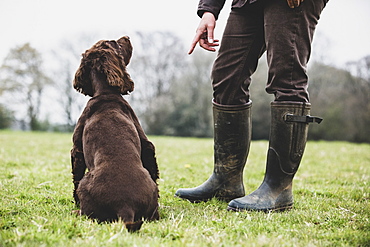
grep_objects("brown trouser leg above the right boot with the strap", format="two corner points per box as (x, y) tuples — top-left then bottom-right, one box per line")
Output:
(264, 0), (327, 102)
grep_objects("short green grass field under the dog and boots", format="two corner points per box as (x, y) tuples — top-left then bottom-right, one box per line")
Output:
(0, 131), (370, 247)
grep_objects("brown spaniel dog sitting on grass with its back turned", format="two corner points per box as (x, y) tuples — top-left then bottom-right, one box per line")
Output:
(71, 37), (159, 231)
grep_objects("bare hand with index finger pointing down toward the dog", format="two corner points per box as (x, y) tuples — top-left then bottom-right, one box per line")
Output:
(188, 12), (219, 55)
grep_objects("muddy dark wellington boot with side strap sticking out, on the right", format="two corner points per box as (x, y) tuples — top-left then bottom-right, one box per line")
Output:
(228, 102), (322, 211)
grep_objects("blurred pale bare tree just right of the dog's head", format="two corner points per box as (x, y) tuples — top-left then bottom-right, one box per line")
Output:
(128, 32), (185, 129)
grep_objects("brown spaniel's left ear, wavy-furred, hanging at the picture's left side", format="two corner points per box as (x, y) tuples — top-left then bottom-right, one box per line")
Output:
(73, 51), (93, 96)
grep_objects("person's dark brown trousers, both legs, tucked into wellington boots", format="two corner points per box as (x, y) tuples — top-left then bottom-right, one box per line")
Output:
(212, 0), (328, 105)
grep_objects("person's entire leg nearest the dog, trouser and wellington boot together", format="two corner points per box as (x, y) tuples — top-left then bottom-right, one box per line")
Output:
(175, 4), (264, 201)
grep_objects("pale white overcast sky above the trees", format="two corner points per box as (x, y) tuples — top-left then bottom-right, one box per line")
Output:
(0, 0), (370, 66)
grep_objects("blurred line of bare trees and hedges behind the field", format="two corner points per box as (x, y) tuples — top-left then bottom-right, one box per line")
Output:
(0, 32), (370, 143)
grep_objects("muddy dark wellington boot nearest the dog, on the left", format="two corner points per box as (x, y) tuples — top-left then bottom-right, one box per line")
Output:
(175, 102), (252, 202)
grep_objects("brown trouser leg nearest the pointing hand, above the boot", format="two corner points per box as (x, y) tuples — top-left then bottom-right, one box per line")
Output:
(212, 1), (265, 105)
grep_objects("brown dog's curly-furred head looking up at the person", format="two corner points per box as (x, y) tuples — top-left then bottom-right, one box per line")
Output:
(73, 36), (134, 96)
